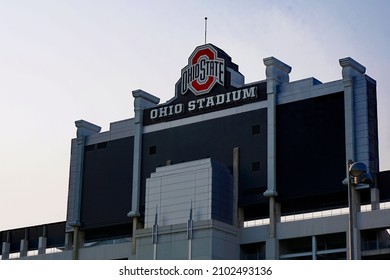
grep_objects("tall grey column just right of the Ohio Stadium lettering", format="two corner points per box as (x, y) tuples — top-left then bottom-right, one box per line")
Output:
(264, 57), (291, 259)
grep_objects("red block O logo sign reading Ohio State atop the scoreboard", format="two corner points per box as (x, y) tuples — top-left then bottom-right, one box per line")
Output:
(180, 45), (225, 95)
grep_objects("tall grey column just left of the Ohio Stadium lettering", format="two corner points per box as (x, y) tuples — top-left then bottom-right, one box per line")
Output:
(127, 89), (160, 255)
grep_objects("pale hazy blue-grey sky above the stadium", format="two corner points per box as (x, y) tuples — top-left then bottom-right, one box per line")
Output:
(0, 0), (390, 231)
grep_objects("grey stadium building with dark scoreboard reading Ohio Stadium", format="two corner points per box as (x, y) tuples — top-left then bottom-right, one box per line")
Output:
(0, 44), (390, 260)
